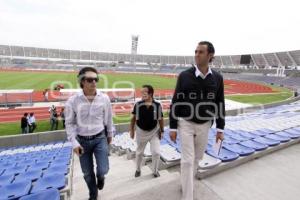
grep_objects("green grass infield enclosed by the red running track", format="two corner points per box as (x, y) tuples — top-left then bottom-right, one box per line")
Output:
(0, 71), (176, 90)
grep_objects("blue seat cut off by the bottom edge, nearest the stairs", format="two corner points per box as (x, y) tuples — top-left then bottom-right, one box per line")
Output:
(19, 188), (60, 200)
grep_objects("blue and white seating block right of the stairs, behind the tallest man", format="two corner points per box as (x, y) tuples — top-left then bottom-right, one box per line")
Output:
(113, 101), (300, 169)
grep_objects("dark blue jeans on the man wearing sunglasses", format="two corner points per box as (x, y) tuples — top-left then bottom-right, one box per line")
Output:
(77, 134), (109, 199)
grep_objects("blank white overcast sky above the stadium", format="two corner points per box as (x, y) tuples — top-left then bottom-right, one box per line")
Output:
(0, 0), (300, 55)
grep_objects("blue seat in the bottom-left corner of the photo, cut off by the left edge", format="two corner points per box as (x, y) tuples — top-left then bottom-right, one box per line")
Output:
(0, 181), (31, 200)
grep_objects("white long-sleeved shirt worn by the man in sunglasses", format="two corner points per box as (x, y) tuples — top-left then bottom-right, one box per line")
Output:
(65, 91), (113, 148)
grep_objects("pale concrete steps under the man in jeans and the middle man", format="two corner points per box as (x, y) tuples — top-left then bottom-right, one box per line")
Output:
(71, 154), (180, 200)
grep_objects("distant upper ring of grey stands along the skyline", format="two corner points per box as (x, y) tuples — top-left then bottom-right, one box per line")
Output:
(0, 45), (300, 68)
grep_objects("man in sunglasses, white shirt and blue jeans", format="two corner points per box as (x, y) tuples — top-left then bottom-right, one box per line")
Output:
(65, 67), (113, 200)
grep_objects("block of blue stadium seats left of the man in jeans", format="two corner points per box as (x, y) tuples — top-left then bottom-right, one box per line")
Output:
(0, 142), (72, 200)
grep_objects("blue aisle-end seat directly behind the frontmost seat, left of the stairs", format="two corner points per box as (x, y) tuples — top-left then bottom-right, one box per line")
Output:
(31, 174), (66, 193)
